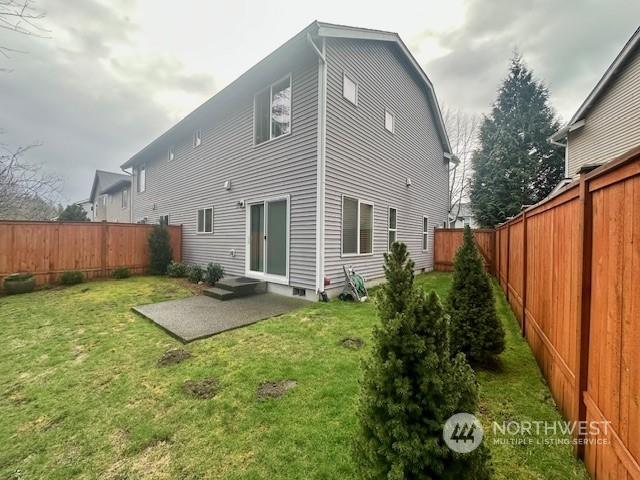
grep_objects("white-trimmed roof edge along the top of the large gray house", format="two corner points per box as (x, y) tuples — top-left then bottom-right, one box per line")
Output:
(121, 21), (452, 168)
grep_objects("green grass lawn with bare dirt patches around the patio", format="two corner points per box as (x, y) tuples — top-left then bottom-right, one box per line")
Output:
(0, 274), (586, 479)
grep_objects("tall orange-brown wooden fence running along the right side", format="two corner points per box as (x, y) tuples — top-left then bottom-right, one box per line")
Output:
(436, 144), (640, 479)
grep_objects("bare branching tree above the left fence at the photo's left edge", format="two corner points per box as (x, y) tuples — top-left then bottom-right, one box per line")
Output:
(0, 137), (60, 220)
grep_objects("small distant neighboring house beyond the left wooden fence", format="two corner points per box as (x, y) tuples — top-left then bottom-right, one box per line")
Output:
(89, 170), (131, 223)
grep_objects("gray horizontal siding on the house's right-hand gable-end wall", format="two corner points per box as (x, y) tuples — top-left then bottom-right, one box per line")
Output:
(325, 39), (448, 286)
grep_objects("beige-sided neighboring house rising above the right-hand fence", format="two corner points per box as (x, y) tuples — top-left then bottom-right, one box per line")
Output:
(550, 28), (640, 179)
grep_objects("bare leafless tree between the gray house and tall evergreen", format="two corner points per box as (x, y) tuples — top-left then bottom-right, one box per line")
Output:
(443, 108), (480, 226)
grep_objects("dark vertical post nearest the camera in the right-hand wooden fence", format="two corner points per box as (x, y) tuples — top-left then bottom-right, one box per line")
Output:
(574, 174), (593, 458)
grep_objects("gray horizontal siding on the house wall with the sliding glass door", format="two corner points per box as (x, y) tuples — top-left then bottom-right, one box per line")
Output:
(133, 54), (318, 288)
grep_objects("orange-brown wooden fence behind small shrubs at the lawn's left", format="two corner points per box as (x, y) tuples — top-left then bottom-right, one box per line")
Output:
(0, 221), (182, 284)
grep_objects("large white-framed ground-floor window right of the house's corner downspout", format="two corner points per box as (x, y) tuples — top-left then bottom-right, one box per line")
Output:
(342, 197), (373, 255)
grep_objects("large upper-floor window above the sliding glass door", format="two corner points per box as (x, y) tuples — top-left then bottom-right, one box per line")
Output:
(253, 75), (291, 145)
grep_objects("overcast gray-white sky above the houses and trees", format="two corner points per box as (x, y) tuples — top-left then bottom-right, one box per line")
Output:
(0, 0), (640, 201)
